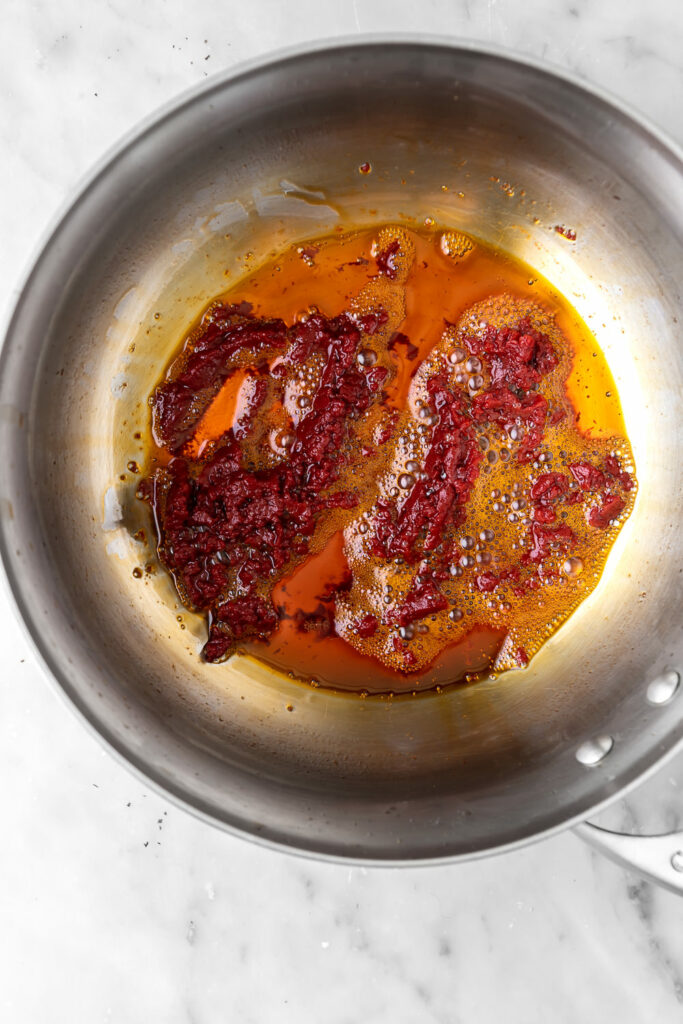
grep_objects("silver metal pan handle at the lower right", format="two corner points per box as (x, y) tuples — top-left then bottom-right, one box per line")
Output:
(573, 821), (683, 896)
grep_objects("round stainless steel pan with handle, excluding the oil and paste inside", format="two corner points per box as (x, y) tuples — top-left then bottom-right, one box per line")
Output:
(0, 39), (683, 890)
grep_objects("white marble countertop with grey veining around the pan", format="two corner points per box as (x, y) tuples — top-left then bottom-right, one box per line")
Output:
(0, 0), (683, 1024)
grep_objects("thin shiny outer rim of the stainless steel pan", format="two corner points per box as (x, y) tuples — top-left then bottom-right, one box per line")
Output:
(0, 33), (683, 867)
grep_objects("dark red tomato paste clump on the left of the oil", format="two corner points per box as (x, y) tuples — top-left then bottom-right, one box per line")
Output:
(152, 307), (393, 660)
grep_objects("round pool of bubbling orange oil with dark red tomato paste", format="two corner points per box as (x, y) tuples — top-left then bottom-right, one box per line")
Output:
(141, 226), (635, 691)
